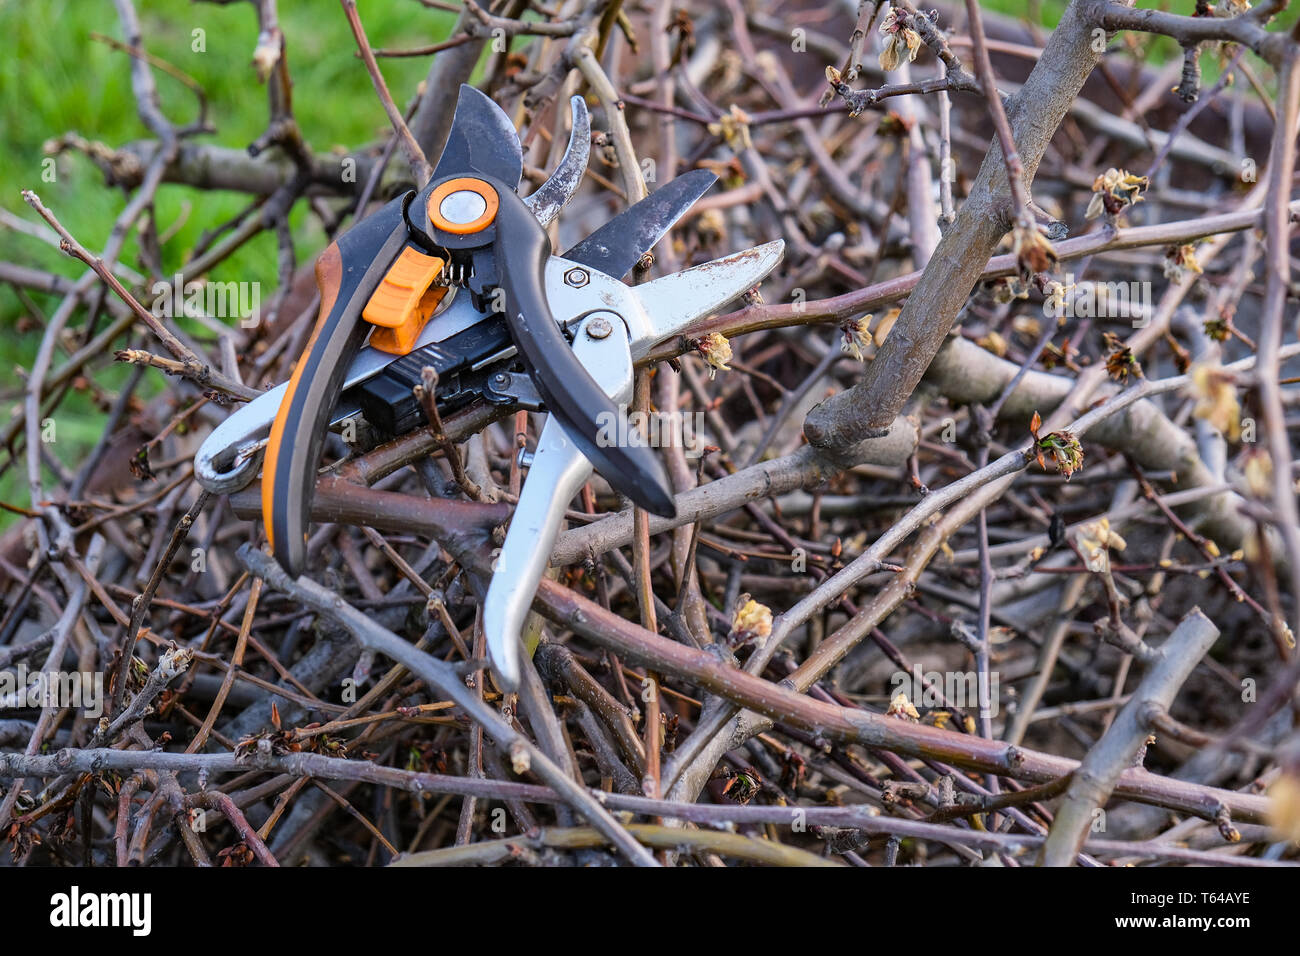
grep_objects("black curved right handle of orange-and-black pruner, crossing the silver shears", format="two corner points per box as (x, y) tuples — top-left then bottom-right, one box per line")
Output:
(494, 190), (677, 518)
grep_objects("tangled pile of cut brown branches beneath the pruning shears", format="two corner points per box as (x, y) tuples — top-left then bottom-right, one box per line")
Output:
(0, 0), (1300, 866)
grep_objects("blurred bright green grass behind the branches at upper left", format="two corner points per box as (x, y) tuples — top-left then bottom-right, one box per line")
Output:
(0, 0), (455, 515)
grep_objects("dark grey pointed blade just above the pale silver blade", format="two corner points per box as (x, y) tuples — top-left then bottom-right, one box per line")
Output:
(563, 169), (718, 278)
